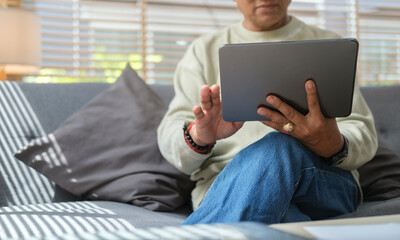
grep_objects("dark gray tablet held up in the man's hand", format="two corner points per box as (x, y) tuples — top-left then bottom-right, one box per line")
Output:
(219, 38), (358, 122)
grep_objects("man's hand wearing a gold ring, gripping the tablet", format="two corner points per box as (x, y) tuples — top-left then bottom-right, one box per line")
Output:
(257, 80), (344, 158)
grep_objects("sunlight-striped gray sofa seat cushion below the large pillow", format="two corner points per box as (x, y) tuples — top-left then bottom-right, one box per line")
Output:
(0, 201), (186, 239)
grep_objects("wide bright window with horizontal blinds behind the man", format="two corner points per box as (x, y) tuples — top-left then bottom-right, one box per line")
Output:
(18, 0), (400, 84)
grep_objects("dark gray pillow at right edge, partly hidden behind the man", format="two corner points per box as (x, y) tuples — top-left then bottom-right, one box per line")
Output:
(358, 142), (400, 201)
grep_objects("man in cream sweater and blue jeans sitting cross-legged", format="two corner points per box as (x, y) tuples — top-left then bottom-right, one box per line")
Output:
(158, 0), (377, 224)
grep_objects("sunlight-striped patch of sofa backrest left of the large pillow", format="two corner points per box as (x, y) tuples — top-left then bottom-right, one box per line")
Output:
(0, 82), (55, 206)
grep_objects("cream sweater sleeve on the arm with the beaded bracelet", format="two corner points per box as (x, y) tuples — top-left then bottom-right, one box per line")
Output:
(157, 41), (211, 174)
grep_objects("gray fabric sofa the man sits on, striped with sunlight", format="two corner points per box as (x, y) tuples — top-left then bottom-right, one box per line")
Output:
(0, 72), (400, 239)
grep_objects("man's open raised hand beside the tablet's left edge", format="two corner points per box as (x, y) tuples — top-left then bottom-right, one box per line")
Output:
(189, 85), (244, 146)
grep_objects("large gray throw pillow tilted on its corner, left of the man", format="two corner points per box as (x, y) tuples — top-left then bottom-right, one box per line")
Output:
(15, 65), (193, 211)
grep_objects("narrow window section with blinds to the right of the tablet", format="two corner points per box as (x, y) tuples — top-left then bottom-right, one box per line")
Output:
(358, 0), (400, 84)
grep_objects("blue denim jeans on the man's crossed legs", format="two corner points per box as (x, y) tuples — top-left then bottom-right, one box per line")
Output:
(183, 132), (359, 225)
